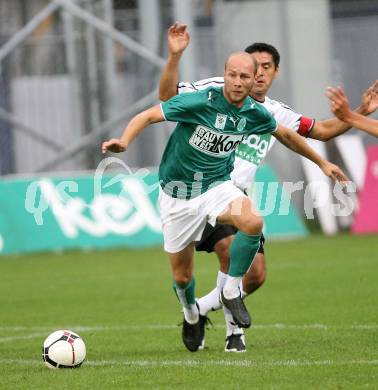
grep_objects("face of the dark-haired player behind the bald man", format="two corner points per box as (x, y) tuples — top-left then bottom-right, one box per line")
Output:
(251, 51), (278, 99)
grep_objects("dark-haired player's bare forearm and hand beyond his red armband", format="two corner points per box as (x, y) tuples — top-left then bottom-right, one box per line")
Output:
(309, 80), (378, 141)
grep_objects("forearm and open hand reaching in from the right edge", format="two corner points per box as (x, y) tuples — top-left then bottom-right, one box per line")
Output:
(326, 87), (378, 137)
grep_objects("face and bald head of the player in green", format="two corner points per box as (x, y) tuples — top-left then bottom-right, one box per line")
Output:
(224, 58), (254, 107)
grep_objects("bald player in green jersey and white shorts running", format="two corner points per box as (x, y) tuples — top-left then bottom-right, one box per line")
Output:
(102, 52), (347, 351)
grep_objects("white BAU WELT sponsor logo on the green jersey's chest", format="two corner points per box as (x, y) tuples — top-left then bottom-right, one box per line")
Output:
(189, 126), (244, 157)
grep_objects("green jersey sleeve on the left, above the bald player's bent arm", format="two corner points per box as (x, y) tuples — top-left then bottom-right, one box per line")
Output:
(160, 92), (206, 123)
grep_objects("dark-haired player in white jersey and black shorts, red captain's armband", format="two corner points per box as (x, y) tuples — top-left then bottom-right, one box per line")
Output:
(159, 23), (378, 352)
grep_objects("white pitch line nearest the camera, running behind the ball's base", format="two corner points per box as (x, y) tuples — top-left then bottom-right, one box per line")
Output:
(0, 359), (378, 368)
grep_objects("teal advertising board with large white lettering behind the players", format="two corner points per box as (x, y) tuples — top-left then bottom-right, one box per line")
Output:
(0, 166), (307, 254)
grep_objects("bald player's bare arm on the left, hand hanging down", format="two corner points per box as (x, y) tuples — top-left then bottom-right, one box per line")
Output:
(101, 105), (165, 153)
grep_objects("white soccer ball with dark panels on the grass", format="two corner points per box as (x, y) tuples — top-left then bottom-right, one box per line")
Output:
(42, 330), (86, 368)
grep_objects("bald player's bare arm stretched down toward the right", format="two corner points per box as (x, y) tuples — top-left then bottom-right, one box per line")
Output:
(273, 125), (349, 183)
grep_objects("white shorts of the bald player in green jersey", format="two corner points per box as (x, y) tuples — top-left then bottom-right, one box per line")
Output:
(159, 180), (246, 253)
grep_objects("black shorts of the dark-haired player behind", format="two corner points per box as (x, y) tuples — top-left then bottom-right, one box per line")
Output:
(196, 223), (265, 253)
